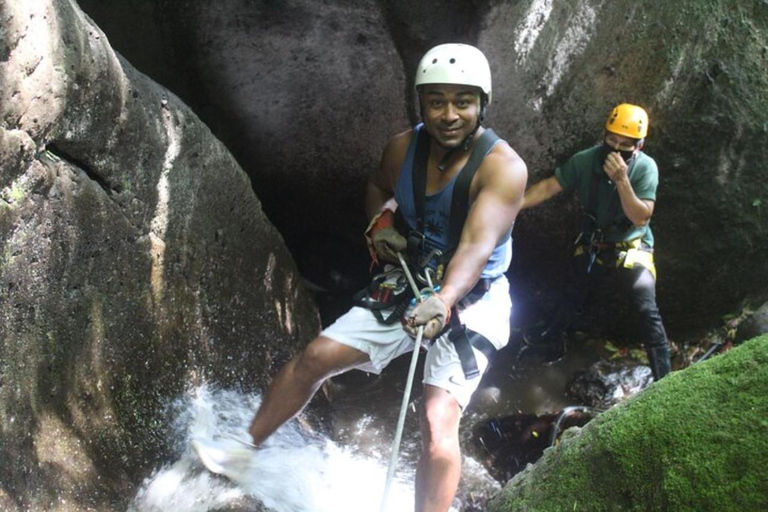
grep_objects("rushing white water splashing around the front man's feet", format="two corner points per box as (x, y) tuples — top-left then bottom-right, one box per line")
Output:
(129, 387), (420, 512)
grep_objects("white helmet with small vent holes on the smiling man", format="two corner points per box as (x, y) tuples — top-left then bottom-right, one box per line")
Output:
(416, 44), (491, 104)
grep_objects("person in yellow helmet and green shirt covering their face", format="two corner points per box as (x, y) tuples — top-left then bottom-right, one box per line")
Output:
(523, 103), (670, 380)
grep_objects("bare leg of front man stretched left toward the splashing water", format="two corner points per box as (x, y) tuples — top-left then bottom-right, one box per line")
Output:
(249, 336), (368, 446)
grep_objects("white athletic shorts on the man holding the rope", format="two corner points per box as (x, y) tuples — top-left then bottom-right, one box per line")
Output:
(321, 276), (512, 409)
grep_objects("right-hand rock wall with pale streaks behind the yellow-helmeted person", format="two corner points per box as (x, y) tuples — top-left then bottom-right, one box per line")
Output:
(478, 0), (768, 335)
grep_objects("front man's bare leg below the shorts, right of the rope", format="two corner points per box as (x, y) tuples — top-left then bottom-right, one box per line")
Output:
(416, 384), (461, 512)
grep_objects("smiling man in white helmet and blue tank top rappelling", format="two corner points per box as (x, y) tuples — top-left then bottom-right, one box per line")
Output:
(213, 44), (527, 512)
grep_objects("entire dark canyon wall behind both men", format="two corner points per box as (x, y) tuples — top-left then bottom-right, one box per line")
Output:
(82, 0), (768, 333)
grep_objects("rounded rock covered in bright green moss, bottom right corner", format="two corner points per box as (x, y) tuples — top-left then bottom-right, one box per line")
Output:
(488, 336), (768, 512)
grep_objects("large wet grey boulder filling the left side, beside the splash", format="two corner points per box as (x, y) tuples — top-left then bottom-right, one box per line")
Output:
(0, 0), (318, 510)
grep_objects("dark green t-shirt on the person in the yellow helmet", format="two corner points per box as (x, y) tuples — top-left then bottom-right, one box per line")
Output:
(555, 146), (659, 247)
